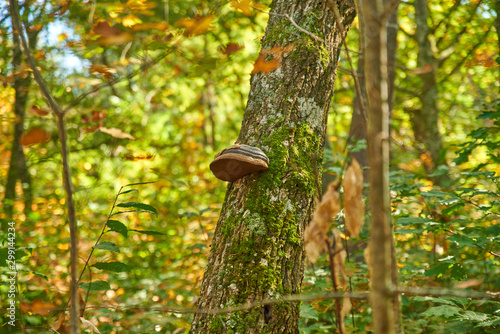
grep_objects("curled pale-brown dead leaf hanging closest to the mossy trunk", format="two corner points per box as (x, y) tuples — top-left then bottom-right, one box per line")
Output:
(304, 180), (340, 263)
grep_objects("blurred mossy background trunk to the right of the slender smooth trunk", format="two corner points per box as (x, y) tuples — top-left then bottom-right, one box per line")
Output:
(410, 0), (445, 173)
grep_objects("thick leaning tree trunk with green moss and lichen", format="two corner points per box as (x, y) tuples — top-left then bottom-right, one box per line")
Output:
(191, 0), (355, 333)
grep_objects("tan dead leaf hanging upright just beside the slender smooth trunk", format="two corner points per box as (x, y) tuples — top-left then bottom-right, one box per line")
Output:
(343, 158), (365, 237)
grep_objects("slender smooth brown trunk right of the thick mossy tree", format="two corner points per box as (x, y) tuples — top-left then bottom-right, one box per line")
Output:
(360, 0), (396, 334)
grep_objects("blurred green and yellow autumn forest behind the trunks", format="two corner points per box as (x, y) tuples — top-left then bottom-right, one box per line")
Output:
(0, 0), (500, 333)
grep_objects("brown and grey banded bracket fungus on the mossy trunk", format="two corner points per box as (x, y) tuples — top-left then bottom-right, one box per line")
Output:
(210, 144), (269, 182)
